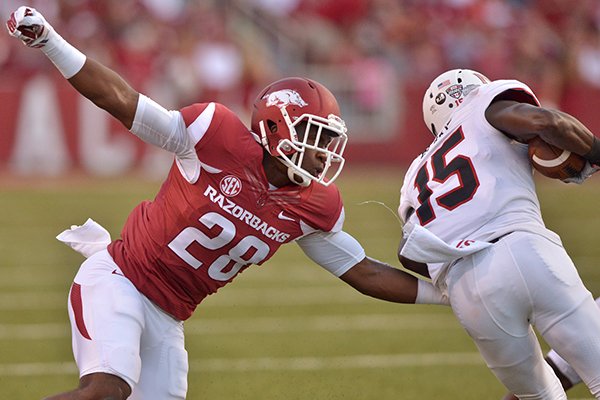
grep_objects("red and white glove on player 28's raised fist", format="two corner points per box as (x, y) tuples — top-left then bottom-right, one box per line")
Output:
(6, 6), (54, 48)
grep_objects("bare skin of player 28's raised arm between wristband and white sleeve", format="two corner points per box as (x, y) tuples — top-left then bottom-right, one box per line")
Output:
(68, 58), (139, 129)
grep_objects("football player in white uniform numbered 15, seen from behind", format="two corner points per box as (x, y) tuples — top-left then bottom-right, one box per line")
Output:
(398, 69), (600, 399)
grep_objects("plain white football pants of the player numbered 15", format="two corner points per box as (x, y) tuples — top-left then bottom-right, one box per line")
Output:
(446, 232), (600, 400)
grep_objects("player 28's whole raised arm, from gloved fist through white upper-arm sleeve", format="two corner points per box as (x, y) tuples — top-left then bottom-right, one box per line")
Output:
(6, 7), (199, 164)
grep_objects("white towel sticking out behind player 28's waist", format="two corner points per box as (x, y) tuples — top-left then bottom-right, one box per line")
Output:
(56, 218), (111, 258)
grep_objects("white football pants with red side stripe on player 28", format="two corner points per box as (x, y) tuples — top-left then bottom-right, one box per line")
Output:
(69, 250), (188, 400)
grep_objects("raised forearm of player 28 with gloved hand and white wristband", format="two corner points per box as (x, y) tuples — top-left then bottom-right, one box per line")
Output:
(6, 7), (139, 129)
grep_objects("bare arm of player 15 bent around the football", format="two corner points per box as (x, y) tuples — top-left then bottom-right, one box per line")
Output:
(485, 100), (594, 155)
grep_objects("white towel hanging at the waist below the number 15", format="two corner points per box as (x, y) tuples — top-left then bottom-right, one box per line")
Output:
(400, 224), (492, 263)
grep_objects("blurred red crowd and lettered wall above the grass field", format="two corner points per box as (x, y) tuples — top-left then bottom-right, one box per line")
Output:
(0, 0), (600, 175)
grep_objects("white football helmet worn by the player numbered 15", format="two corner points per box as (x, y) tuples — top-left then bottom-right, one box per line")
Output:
(423, 69), (490, 137)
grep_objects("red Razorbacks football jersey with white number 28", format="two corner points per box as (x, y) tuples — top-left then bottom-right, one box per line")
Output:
(108, 103), (343, 320)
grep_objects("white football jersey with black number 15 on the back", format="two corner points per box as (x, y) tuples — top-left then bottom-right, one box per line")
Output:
(398, 80), (548, 281)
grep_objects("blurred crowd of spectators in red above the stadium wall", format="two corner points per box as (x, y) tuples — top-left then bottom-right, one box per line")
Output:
(0, 0), (600, 120)
